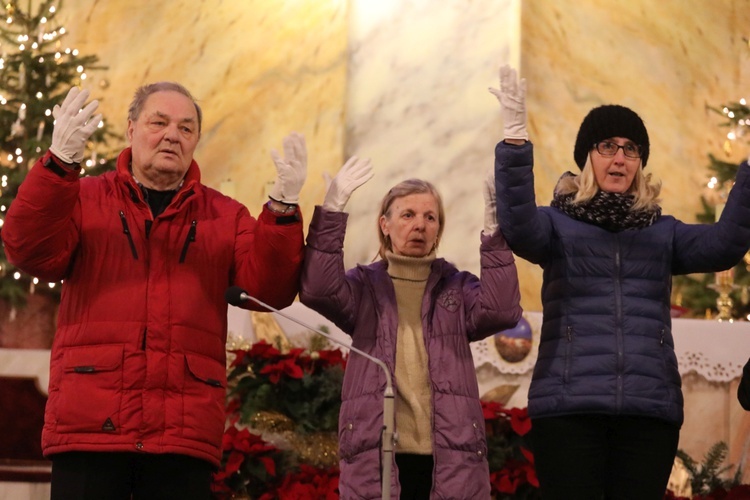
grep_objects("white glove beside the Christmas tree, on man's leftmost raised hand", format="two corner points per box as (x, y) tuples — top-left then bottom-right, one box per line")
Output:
(49, 87), (102, 163)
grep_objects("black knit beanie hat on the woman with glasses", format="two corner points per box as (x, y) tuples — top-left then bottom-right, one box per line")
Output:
(573, 104), (649, 170)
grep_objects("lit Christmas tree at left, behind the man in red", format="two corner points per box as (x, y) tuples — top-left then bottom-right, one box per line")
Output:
(0, 0), (116, 304)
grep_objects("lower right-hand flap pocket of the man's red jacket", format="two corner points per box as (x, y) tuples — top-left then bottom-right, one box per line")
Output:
(182, 353), (226, 446)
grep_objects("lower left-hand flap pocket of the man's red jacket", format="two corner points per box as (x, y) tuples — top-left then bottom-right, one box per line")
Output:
(53, 344), (123, 434)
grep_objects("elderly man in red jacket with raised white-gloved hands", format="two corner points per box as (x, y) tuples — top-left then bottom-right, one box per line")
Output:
(2, 82), (307, 499)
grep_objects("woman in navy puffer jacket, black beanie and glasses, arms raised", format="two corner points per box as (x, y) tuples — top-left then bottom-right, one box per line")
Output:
(490, 66), (750, 500)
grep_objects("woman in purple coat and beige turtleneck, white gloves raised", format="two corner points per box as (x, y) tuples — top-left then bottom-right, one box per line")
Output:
(300, 157), (522, 499)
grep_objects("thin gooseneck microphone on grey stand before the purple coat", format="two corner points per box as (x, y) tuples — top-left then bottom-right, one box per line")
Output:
(224, 286), (398, 500)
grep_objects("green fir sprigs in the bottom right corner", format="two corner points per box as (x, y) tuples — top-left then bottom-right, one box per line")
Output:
(677, 441), (742, 496)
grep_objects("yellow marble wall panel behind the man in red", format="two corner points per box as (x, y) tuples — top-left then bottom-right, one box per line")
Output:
(59, 0), (347, 223)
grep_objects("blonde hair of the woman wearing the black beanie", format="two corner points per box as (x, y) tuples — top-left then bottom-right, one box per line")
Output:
(555, 153), (661, 211)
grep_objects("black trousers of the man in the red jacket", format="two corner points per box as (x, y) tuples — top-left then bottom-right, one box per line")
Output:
(50, 452), (213, 500)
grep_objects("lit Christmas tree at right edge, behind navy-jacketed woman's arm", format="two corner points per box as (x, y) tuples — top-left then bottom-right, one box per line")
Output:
(673, 49), (750, 319)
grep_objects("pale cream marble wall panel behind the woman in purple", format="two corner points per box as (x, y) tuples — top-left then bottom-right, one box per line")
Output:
(345, 0), (521, 266)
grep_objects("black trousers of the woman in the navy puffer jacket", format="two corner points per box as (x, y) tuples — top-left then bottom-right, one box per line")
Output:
(530, 415), (680, 500)
